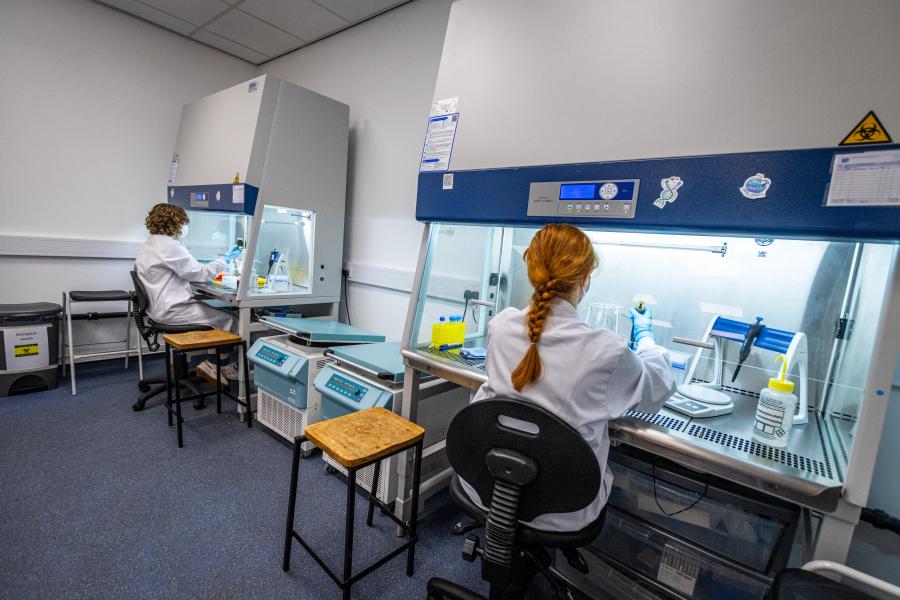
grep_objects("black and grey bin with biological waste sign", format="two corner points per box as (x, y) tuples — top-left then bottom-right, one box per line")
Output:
(0, 302), (62, 396)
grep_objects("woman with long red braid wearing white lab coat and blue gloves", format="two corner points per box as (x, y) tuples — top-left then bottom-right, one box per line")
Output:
(462, 224), (675, 531)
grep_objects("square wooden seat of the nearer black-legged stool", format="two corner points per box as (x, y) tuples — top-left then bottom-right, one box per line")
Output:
(304, 408), (425, 469)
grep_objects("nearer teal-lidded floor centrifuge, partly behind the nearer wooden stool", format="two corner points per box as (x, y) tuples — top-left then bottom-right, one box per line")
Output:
(314, 342), (469, 504)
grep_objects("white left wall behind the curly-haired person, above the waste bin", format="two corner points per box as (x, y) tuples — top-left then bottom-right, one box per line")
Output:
(0, 0), (256, 352)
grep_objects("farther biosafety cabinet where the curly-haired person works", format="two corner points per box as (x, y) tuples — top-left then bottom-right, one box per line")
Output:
(167, 75), (349, 334)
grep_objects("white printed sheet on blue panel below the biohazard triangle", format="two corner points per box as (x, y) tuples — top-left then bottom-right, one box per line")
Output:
(825, 150), (900, 207)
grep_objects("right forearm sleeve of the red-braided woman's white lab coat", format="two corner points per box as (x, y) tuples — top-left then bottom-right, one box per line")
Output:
(607, 340), (675, 419)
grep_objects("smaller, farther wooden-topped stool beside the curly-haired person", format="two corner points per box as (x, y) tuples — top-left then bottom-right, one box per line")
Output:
(163, 329), (253, 448)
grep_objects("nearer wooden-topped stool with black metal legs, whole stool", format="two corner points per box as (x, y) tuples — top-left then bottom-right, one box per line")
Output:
(281, 408), (425, 600)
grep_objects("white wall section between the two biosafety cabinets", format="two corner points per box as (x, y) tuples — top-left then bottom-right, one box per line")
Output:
(260, 0), (450, 340)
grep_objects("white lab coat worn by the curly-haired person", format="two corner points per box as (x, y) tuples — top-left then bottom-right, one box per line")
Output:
(134, 235), (237, 332)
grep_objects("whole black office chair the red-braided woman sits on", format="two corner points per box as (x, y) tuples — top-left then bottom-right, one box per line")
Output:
(428, 398), (606, 600)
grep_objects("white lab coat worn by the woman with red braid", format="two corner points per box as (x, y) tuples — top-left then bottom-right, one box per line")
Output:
(462, 298), (675, 531)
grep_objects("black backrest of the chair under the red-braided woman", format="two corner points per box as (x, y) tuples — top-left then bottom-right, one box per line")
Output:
(447, 398), (602, 521)
